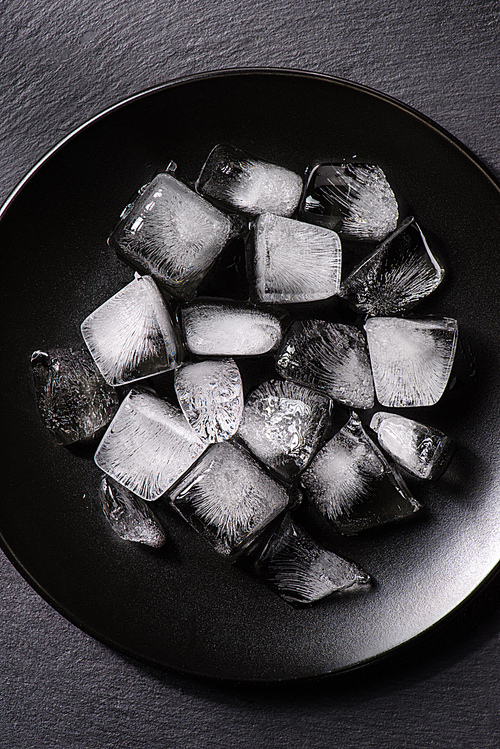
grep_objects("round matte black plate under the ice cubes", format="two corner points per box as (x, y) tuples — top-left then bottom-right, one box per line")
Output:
(0, 71), (500, 680)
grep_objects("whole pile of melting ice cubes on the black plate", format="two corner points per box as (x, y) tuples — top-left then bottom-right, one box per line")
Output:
(32, 146), (457, 604)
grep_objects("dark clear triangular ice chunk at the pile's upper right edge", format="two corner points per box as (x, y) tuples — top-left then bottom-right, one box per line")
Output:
(339, 218), (444, 315)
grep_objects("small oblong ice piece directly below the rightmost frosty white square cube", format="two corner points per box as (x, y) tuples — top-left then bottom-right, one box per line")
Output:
(370, 411), (455, 479)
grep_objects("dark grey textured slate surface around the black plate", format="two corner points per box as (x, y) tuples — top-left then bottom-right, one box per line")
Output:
(0, 0), (500, 749)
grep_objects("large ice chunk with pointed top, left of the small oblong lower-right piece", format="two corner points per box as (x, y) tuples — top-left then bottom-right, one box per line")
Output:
(301, 414), (419, 534)
